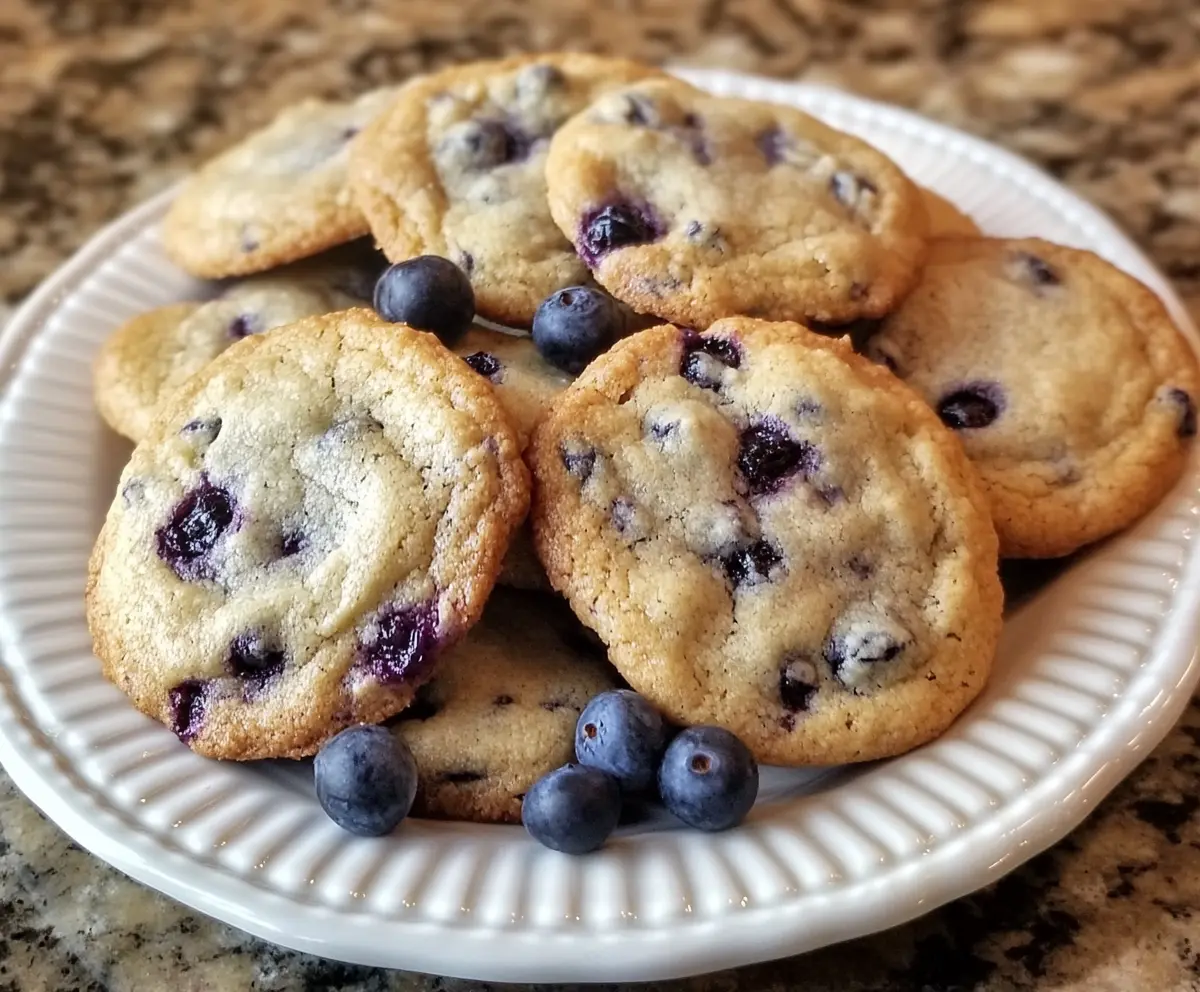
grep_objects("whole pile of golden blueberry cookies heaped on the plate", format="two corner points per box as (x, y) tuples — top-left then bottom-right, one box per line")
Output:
(88, 54), (1200, 820)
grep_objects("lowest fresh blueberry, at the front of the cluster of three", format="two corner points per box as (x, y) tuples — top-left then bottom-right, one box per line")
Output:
(521, 764), (620, 854)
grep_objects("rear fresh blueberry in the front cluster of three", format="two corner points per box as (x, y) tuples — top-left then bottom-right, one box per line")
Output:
(575, 689), (668, 793)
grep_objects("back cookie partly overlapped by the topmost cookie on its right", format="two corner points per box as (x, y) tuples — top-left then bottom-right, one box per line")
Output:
(350, 53), (660, 327)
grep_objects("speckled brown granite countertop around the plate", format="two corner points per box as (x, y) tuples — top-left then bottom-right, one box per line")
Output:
(0, 0), (1200, 992)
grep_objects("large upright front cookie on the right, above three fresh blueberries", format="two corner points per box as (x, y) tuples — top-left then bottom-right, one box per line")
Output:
(530, 318), (1002, 764)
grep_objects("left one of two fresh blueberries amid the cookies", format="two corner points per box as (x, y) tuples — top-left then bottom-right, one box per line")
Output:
(374, 254), (475, 347)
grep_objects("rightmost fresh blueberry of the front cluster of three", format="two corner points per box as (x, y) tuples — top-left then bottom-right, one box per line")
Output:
(659, 727), (758, 830)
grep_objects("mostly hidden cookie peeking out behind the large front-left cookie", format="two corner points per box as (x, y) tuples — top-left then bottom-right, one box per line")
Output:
(92, 248), (382, 441)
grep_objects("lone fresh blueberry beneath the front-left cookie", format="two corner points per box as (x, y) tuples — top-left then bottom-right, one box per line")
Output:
(313, 726), (416, 837)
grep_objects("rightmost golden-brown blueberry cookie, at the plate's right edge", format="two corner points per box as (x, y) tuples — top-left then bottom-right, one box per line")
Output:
(865, 239), (1198, 558)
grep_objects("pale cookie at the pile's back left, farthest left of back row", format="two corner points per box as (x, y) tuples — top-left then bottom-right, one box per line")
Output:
(162, 88), (400, 278)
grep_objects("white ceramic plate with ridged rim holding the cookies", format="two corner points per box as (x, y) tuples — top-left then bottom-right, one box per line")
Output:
(0, 72), (1200, 981)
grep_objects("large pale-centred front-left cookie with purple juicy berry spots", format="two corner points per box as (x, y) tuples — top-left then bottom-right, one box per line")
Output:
(88, 309), (528, 759)
